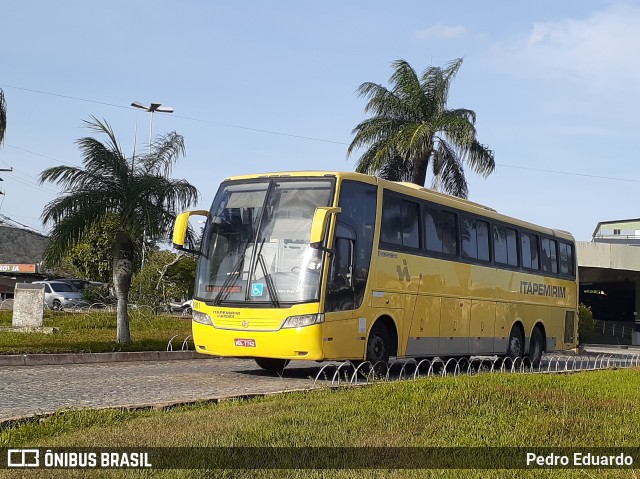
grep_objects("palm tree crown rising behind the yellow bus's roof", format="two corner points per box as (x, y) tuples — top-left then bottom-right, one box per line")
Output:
(347, 58), (495, 198)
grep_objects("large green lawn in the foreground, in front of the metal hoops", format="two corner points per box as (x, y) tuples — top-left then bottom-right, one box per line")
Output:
(0, 370), (640, 479)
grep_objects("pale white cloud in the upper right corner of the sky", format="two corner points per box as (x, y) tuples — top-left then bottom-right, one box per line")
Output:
(494, 6), (640, 90)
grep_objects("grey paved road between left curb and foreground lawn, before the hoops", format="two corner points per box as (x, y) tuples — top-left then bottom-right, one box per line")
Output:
(0, 358), (319, 422)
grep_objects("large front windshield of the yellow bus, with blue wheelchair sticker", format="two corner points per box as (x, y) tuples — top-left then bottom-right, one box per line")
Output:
(195, 178), (334, 307)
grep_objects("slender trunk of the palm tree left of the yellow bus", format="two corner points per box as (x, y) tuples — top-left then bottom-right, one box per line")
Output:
(113, 231), (134, 343)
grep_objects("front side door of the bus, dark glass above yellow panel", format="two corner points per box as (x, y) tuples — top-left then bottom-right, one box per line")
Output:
(323, 221), (362, 359)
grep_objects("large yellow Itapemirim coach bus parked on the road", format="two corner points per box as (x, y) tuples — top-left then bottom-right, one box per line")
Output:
(173, 171), (578, 371)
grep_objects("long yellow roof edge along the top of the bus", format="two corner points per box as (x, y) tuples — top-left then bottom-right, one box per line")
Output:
(225, 170), (574, 242)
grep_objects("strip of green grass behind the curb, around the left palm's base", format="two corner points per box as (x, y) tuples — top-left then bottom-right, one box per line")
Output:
(0, 310), (191, 354)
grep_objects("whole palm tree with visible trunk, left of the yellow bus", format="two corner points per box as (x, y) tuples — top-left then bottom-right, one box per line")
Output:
(40, 117), (198, 343)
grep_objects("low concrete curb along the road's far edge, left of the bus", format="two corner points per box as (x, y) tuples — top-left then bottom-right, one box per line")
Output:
(0, 351), (213, 366)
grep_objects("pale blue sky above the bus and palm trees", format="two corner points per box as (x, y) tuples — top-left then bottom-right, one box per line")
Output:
(0, 0), (640, 241)
